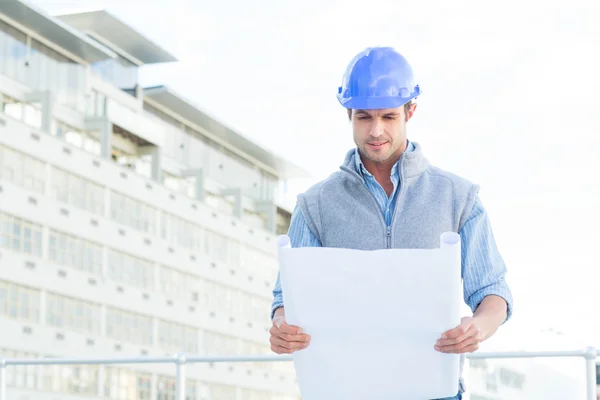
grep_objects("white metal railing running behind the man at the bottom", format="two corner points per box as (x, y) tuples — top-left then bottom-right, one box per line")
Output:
(0, 347), (600, 400)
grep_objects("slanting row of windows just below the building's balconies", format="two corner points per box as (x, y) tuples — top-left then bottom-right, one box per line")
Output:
(0, 145), (276, 269)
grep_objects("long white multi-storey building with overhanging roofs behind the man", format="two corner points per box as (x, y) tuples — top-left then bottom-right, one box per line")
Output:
(0, 0), (307, 400)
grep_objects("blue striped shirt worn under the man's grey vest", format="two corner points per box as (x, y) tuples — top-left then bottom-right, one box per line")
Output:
(271, 142), (512, 322)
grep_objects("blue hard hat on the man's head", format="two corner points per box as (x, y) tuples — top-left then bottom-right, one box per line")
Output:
(337, 47), (421, 110)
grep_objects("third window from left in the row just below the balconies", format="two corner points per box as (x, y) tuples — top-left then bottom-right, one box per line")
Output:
(110, 191), (157, 235)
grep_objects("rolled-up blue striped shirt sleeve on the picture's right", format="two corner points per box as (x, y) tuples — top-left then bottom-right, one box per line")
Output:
(460, 197), (513, 322)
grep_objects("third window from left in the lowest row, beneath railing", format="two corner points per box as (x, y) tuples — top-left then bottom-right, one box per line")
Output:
(104, 367), (152, 400)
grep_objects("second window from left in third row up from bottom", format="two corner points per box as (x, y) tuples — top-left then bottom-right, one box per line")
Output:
(48, 229), (102, 275)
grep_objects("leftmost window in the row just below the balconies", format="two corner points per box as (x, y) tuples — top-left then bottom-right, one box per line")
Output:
(0, 145), (46, 194)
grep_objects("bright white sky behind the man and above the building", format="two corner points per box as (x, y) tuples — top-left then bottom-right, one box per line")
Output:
(33, 0), (600, 347)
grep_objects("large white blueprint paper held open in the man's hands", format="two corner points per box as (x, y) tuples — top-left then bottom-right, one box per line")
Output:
(279, 232), (462, 400)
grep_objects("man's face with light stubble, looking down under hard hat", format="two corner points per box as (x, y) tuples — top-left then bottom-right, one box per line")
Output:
(352, 105), (416, 164)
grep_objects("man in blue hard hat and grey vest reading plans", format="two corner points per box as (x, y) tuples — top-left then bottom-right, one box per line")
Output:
(270, 48), (512, 399)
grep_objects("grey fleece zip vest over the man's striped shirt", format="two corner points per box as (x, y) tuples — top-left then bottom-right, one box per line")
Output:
(298, 142), (479, 392)
